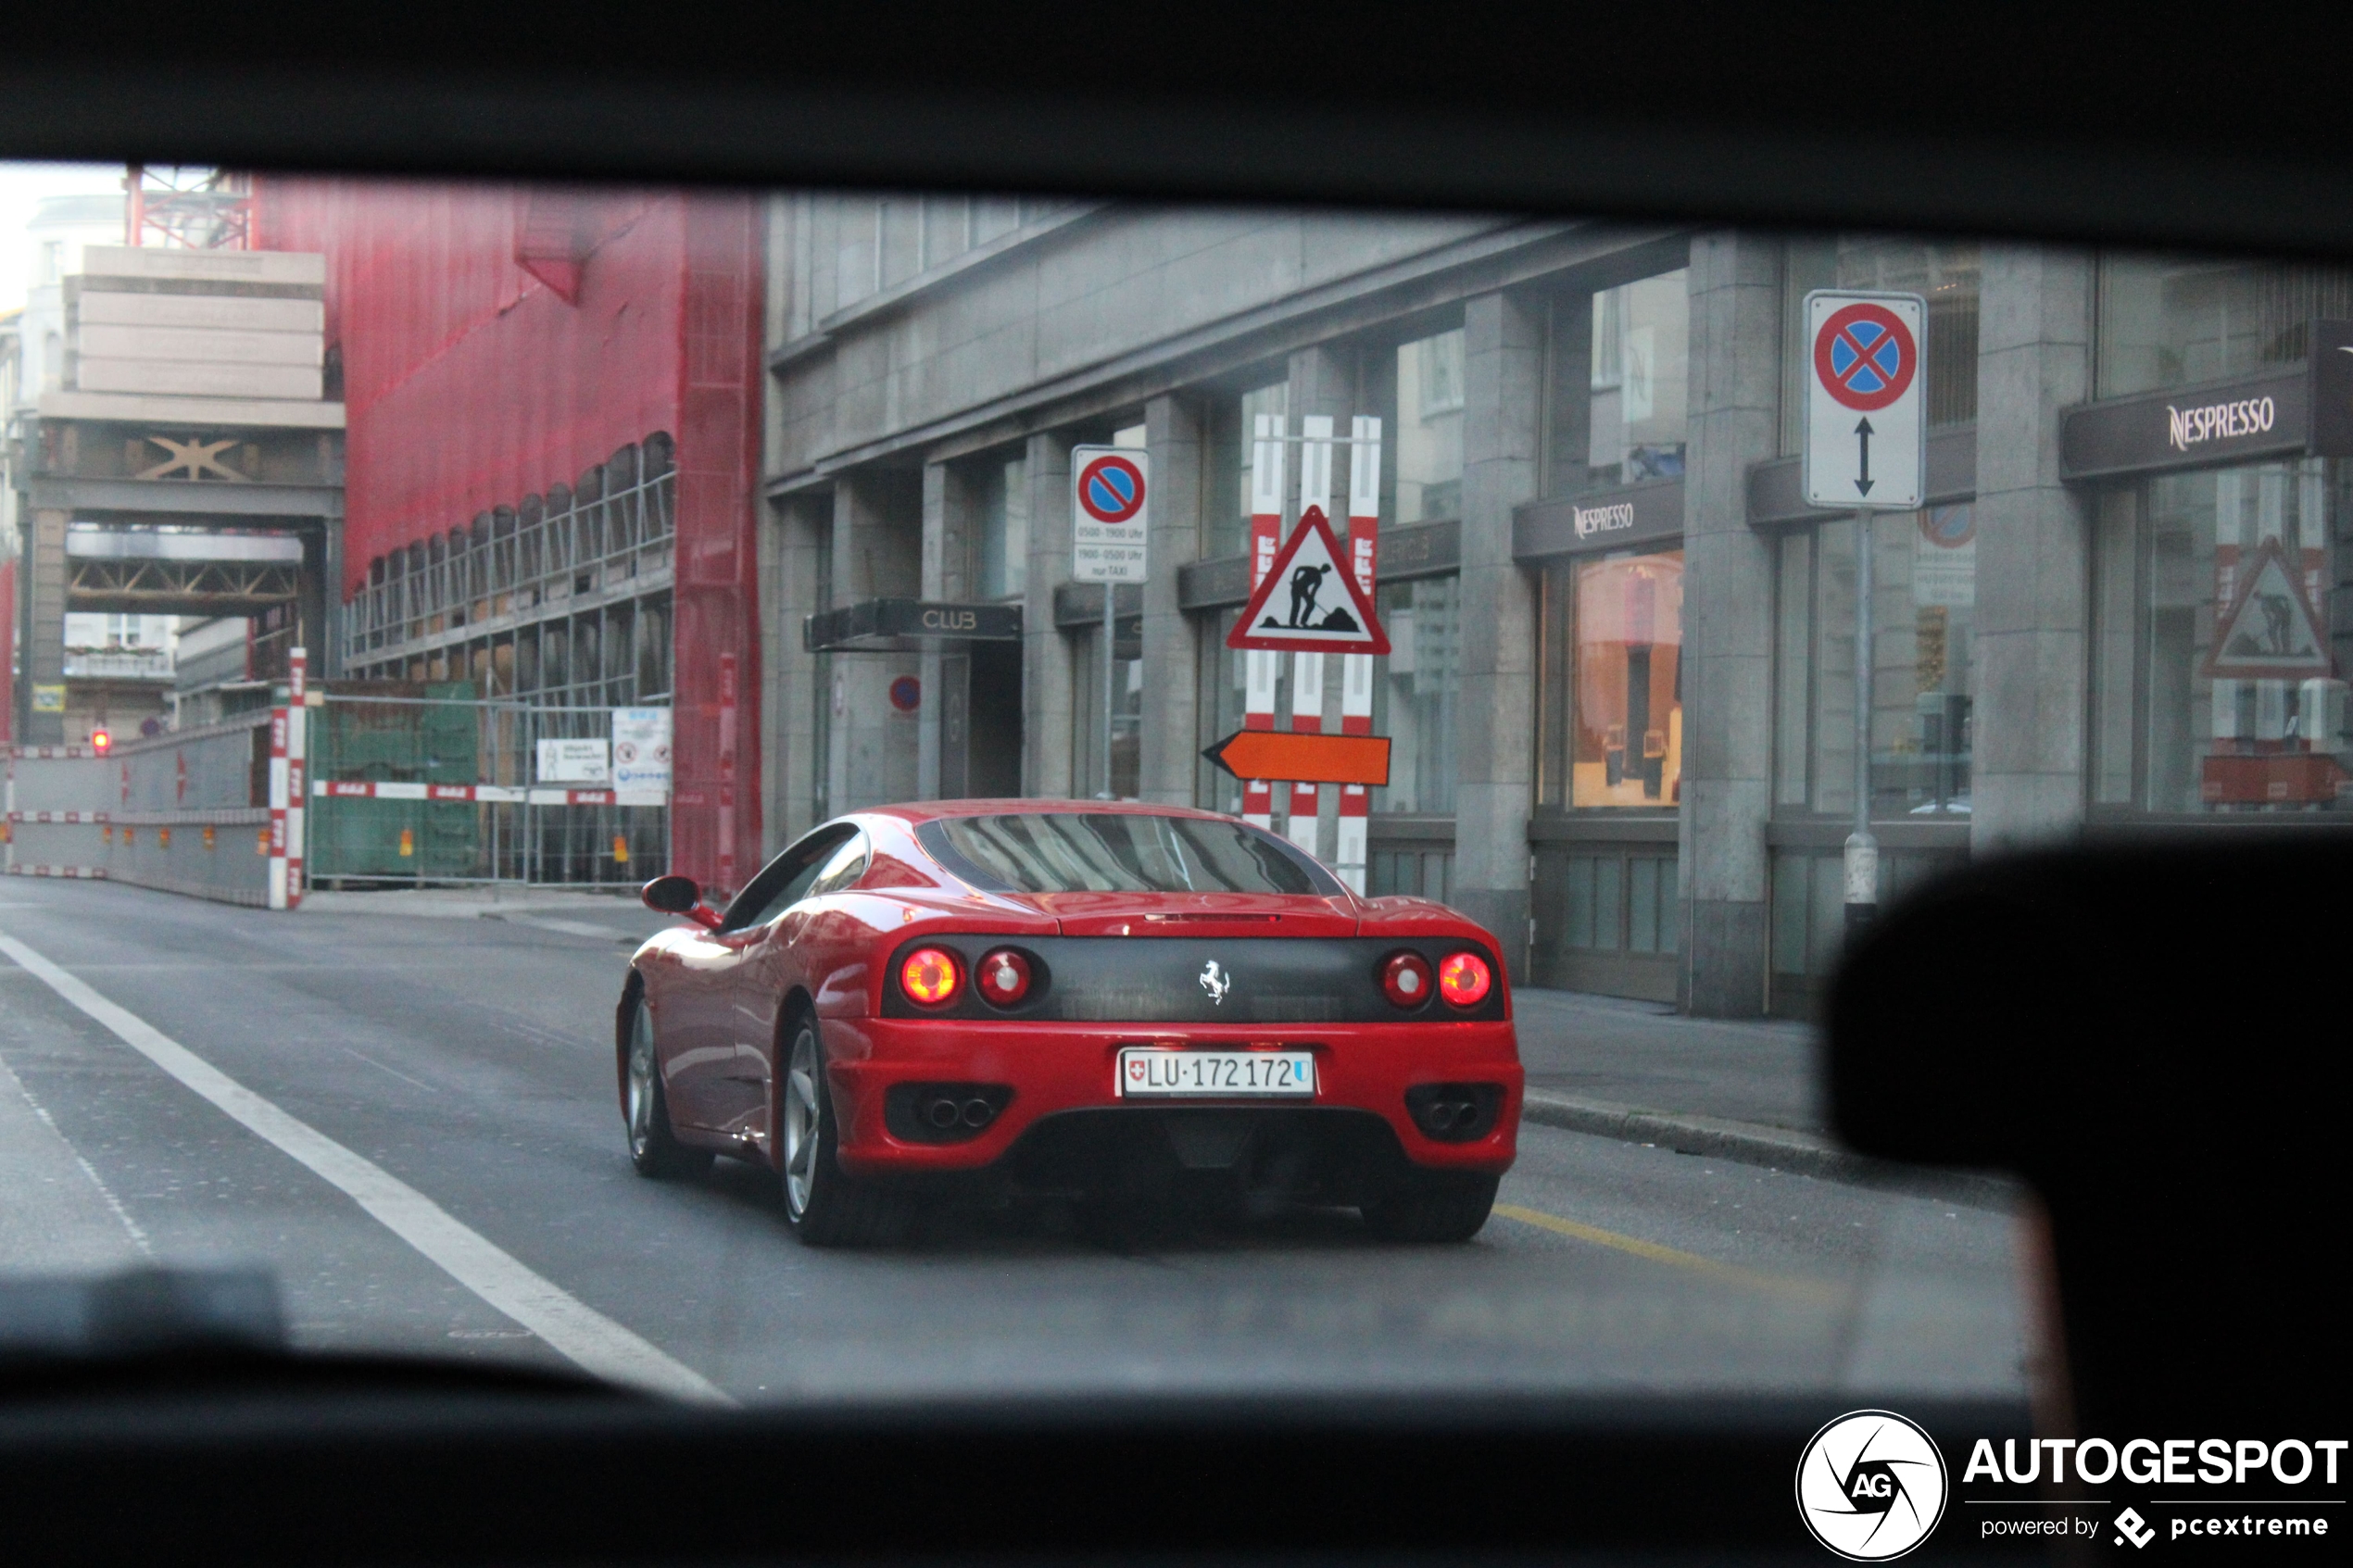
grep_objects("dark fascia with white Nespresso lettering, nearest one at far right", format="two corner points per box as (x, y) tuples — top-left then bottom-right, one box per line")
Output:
(2059, 322), (2353, 480)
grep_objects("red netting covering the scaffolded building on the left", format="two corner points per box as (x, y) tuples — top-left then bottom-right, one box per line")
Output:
(254, 176), (760, 888)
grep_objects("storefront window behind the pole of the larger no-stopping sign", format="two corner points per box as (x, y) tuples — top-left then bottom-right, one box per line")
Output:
(1774, 506), (1977, 818)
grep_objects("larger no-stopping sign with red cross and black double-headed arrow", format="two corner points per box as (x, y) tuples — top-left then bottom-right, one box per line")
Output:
(1805, 289), (1927, 510)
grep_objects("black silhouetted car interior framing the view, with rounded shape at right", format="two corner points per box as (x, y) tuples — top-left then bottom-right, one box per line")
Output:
(0, 0), (2353, 1563)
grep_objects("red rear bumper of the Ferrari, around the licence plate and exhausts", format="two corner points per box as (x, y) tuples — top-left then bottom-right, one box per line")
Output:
(824, 1018), (1522, 1187)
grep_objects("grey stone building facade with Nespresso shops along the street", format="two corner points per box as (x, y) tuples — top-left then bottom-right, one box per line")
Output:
(760, 195), (2353, 1016)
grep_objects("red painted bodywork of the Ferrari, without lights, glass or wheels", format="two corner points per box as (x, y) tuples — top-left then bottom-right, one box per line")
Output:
(623, 799), (1522, 1178)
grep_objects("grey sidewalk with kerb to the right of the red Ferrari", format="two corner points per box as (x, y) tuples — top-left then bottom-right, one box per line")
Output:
(1511, 987), (2017, 1209)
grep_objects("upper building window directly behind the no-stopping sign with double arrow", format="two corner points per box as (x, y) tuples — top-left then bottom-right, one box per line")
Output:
(1781, 235), (1982, 454)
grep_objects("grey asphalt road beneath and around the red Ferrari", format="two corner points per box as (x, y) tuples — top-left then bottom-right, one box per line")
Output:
(0, 879), (2023, 1401)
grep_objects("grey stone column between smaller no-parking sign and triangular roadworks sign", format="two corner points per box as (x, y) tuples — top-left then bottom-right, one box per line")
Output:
(1137, 395), (1202, 807)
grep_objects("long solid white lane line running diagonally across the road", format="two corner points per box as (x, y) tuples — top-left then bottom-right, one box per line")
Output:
(0, 935), (734, 1406)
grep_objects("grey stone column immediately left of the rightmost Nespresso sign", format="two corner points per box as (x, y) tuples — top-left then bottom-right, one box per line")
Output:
(1969, 245), (2092, 853)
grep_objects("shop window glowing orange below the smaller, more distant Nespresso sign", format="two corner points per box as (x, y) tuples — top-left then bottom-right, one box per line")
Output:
(1567, 550), (1682, 809)
